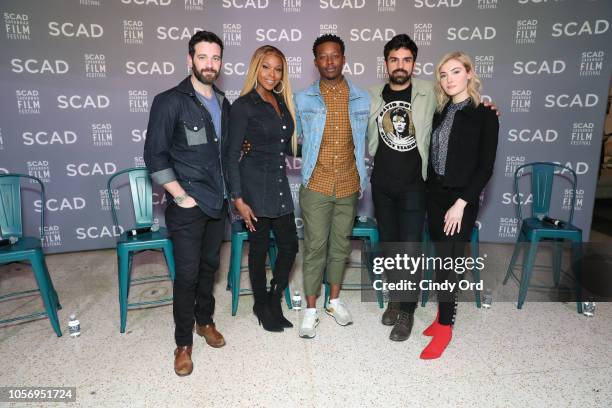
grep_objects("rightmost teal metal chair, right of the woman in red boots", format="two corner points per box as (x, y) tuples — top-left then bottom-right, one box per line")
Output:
(503, 162), (582, 313)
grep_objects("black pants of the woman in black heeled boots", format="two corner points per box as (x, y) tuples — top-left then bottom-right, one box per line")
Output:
(249, 213), (298, 303)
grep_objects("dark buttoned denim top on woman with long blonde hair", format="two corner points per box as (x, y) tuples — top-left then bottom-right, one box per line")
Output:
(225, 90), (294, 218)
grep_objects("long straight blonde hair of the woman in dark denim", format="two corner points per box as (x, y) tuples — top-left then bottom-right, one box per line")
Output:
(240, 45), (297, 155)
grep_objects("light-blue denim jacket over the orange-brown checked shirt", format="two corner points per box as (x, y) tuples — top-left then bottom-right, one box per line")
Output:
(294, 78), (370, 191)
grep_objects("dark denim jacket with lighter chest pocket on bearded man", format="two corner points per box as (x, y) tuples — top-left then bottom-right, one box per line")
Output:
(144, 77), (230, 218)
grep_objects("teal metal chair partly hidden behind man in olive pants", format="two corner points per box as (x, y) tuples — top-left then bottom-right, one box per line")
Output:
(323, 217), (385, 309)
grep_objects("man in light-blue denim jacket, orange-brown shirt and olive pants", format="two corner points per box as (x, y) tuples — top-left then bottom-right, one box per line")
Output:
(295, 34), (370, 338)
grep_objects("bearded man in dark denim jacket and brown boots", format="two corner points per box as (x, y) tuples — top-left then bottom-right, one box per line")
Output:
(144, 31), (230, 376)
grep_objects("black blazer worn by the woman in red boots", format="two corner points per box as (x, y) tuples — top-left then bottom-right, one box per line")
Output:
(428, 103), (499, 204)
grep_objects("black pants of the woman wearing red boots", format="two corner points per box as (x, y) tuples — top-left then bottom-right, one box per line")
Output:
(427, 176), (479, 325)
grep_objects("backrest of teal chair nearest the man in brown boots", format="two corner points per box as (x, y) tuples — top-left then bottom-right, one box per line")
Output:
(107, 167), (153, 228)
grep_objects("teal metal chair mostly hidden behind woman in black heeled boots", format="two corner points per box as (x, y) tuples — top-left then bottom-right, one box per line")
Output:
(226, 221), (291, 316)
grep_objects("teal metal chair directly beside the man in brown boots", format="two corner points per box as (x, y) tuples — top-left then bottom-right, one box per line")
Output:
(107, 167), (175, 333)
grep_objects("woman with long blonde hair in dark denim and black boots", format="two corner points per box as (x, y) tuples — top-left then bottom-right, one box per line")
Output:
(225, 45), (298, 332)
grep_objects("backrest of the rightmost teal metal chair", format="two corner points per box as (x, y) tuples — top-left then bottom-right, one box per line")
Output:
(514, 162), (577, 223)
